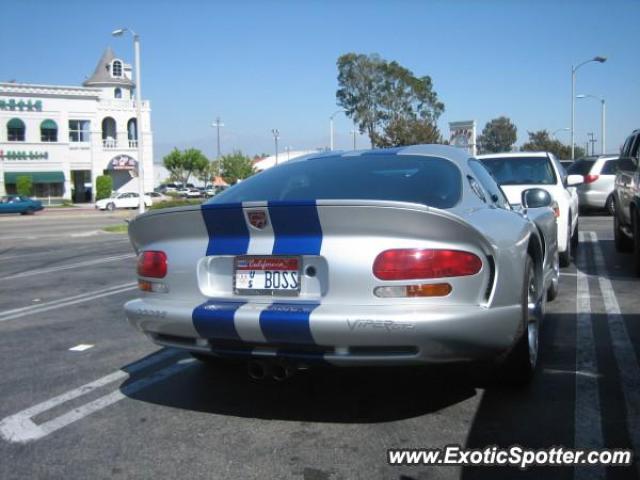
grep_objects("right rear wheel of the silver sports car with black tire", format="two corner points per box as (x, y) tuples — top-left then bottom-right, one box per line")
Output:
(499, 256), (542, 386)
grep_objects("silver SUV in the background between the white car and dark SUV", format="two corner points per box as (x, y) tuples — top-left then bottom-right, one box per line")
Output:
(567, 155), (618, 215)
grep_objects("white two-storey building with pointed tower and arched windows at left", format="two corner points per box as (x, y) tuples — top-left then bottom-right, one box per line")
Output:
(0, 48), (154, 202)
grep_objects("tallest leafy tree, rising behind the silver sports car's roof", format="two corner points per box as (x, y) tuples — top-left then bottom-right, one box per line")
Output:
(336, 53), (444, 147)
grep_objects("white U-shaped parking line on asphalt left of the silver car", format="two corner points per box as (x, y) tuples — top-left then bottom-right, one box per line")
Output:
(0, 349), (190, 443)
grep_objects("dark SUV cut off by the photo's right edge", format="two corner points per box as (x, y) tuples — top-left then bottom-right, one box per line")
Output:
(613, 129), (640, 275)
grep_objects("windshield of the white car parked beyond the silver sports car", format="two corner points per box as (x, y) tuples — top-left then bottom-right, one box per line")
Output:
(480, 157), (556, 185)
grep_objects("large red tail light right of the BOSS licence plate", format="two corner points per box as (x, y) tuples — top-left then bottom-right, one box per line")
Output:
(373, 249), (482, 280)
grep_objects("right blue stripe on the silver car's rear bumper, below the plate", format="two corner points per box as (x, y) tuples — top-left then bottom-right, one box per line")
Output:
(260, 303), (319, 345)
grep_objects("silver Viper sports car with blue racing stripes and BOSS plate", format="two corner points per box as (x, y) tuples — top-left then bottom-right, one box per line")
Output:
(125, 145), (558, 382)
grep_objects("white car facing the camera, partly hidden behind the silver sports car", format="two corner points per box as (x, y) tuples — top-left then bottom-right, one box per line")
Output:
(478, 152), (584, 267)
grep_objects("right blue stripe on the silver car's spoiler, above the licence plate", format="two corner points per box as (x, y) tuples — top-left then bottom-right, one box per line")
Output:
(269, 200), (322, 255)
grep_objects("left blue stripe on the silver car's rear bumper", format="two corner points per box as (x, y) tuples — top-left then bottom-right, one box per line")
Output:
(191, 300), (244, 340)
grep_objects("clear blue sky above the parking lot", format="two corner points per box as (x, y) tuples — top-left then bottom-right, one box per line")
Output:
(0, 0), (640, 161)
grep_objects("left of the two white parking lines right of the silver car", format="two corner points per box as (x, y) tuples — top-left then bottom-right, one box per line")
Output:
(573, 232), (605, 479)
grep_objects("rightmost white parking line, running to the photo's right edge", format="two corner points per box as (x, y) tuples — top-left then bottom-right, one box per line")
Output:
(589, 232), (640, 474)
